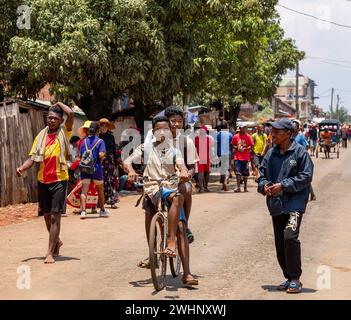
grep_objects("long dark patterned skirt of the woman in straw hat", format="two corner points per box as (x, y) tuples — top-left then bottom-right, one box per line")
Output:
(102, 156), (119, 205)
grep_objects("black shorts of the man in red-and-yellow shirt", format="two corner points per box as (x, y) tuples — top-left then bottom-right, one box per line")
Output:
(38, 181), (67, 216)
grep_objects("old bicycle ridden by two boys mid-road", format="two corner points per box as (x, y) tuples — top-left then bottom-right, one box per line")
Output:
(134, 178), (186, 291)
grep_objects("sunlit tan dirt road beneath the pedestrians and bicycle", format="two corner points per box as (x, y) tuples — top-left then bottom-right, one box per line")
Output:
(0, 149), (351, 300)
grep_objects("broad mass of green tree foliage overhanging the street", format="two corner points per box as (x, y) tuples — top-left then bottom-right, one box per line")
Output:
(0, 0), (303, 119)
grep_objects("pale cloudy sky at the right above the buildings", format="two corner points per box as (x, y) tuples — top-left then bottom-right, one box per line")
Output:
(277, 0), (351, 113)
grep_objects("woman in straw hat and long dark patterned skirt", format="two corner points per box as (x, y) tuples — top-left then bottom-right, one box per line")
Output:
(99, 118), (119, 209)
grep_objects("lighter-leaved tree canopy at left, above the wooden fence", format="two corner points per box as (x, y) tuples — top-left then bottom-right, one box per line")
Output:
(10, 0), (164, 119)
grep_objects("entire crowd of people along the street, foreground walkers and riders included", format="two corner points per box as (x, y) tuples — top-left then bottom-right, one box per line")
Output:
(17, 102), (351, 293)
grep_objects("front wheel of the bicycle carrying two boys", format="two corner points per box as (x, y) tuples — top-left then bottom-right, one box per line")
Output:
(149, 212), (167, 291)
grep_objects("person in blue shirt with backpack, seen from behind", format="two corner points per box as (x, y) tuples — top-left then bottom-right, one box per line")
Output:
(79, 121), (108, 219)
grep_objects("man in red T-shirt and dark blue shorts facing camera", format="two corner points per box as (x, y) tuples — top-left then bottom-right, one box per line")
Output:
(232, 124), (254, 192)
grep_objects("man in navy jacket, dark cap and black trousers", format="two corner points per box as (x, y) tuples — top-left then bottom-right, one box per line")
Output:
(258, 118), (313, 293)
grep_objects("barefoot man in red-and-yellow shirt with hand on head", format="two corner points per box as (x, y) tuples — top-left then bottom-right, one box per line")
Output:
(16, 102), (74, 264)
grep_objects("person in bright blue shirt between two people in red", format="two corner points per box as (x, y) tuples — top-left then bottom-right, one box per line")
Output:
(217, 120), (233, 191)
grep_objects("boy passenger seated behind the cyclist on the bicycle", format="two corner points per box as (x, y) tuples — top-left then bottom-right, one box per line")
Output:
(165, 106), (199, 243)
